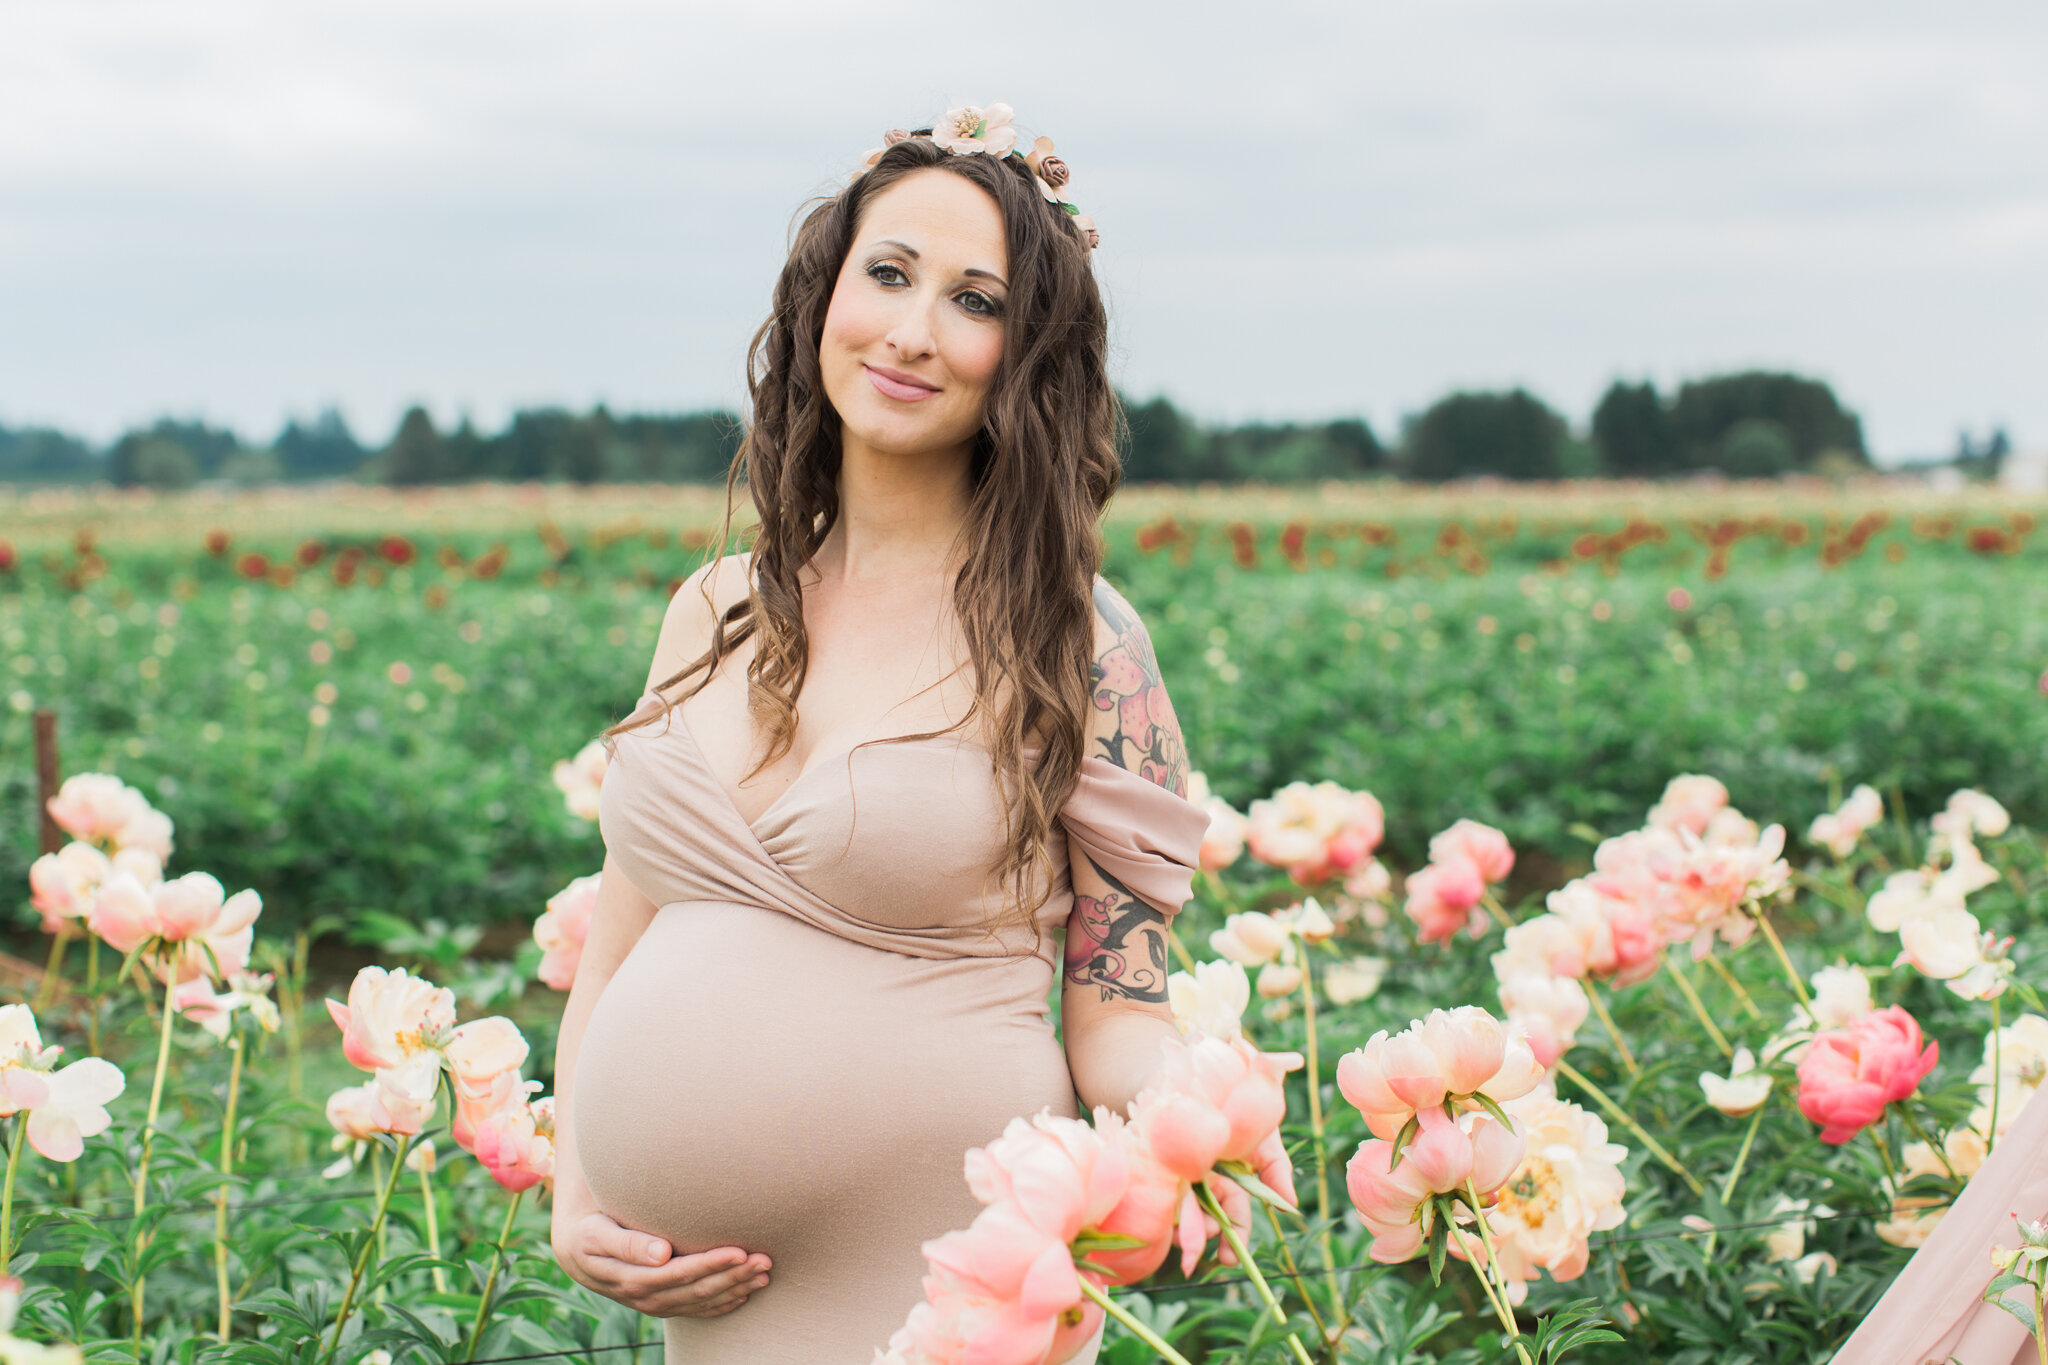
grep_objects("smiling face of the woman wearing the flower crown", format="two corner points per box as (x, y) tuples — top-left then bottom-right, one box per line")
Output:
(819, 170), (1010, 454)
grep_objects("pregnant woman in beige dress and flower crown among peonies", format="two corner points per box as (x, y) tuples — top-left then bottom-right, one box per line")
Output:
(553, 104), (1206, 1365)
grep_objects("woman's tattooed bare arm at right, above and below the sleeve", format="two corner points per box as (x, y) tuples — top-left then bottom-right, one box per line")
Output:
(1061, 579), (1188, 1113)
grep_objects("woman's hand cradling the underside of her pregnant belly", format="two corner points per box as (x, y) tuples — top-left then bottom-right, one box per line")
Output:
(553, 1214), (768, 1318)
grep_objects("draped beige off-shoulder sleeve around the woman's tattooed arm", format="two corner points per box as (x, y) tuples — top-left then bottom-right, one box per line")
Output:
(1059, 755), (1208, 915)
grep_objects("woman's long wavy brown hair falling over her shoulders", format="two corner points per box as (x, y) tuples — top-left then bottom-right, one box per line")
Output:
(606, 129), (1124, 929)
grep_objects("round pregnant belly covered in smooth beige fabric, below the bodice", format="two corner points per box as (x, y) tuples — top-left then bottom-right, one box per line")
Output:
(573, 902), (1075, 1283)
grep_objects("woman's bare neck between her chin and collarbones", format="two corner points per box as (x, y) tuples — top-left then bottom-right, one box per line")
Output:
(813, 440), (971, 587)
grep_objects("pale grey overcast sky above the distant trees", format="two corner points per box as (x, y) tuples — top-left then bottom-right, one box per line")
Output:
(0, 0), (2048, 460)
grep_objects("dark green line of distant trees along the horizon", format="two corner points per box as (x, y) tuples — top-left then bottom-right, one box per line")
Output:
(0, 370), (1916, 487)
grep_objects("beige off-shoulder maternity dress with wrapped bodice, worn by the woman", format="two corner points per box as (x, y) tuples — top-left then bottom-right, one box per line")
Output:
(573, 692), (1208, 1365)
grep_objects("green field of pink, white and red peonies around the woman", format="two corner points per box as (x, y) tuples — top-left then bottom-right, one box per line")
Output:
(0, 479), (2048, 1365)
